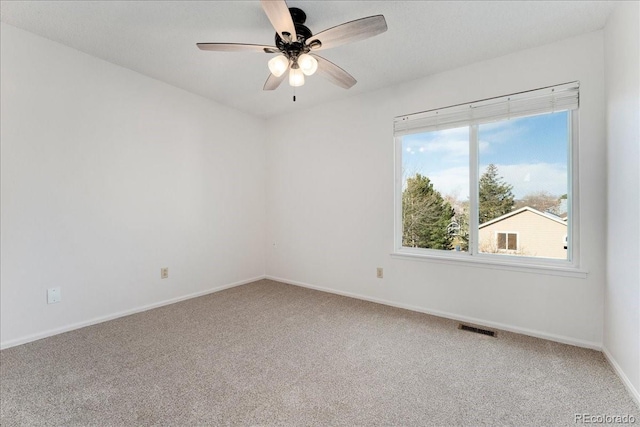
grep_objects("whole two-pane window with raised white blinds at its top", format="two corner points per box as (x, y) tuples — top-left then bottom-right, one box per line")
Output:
(394, 82), (579, 268)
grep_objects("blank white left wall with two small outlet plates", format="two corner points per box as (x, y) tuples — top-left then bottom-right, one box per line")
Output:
(0, 24), (265, 347)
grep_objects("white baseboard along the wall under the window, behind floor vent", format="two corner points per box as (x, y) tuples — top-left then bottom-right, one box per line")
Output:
(265, 275), (602, 351)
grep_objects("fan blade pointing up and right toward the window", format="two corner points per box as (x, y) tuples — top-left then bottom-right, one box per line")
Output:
(306, 15), (387, 51)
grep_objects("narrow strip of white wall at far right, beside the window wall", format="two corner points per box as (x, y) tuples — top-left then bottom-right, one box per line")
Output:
(604, 2), (640, 403)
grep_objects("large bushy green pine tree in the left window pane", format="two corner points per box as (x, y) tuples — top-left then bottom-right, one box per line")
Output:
(402, 174), (455, 250)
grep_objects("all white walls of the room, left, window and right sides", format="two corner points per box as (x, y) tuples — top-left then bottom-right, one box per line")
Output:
(0, 9), (640, 397)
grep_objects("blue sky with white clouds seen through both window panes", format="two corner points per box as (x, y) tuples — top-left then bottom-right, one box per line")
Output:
(402, 112), (569, 200)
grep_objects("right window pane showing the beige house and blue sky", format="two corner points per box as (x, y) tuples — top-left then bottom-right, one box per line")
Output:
(478, 111), (570, 259)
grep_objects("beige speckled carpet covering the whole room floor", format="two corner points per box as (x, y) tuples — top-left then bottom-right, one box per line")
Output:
(0, 280), (640, 426)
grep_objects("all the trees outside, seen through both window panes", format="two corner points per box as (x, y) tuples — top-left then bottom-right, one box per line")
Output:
(402, 164), (567, 251)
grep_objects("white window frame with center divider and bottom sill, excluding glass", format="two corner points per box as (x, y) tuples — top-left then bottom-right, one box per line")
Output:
(391, 82), (588, 278)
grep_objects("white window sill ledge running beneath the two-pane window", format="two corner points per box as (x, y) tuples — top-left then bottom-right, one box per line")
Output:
(391, 252), (588, 279)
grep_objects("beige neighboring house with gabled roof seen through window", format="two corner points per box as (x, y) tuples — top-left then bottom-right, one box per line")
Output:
(479, 206), (567, 259)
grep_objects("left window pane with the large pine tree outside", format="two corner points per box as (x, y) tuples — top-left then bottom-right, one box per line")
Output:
(402, 126), (469, 251)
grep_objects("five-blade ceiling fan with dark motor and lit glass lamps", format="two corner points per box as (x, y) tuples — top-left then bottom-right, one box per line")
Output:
(197, 0), (387, 92)
